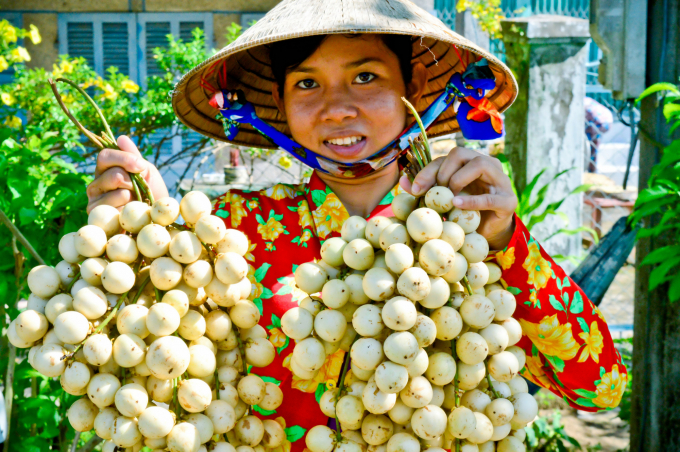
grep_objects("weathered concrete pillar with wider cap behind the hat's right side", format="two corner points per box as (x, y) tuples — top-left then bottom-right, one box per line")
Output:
(502, 15), (589, 271)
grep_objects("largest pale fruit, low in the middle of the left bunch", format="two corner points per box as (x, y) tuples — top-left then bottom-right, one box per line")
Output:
(146, 336), (191, 380)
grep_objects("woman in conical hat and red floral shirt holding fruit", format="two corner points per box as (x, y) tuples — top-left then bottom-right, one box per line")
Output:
(88, 0), (627, 450)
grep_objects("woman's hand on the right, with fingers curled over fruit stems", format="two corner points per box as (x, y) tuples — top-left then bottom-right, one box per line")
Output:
(399, 147), (517, 250)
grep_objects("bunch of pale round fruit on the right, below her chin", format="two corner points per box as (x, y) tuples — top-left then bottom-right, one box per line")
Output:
(281, 187), (538, 452)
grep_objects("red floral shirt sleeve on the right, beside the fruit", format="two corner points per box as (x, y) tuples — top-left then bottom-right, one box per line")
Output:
(493, 216), (628, 411)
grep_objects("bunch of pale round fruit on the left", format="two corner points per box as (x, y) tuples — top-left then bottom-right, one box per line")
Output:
(7, 192), (286, 452)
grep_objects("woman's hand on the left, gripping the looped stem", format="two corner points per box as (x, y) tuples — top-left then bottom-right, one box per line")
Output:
(87, 135), (168, 213)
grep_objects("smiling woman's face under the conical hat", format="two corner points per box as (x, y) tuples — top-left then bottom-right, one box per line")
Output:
(273, 35), (425, 162)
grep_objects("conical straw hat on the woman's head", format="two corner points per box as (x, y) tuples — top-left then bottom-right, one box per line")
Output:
(172, 0), (517, 148)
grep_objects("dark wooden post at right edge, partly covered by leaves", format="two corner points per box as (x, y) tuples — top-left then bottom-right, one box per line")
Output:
(630, 0), (680, 452)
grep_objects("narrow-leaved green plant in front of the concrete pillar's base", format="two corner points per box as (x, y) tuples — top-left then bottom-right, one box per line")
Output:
(496, 154), (599, 243)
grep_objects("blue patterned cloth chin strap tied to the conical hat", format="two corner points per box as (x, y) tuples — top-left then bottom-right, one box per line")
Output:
(216, 59), (503, 178)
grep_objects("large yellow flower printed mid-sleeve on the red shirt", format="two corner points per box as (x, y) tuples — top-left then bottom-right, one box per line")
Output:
(519, 314), (579, 361)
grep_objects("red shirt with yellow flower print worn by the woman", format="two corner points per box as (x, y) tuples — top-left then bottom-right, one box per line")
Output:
(214, 173), (627, 452)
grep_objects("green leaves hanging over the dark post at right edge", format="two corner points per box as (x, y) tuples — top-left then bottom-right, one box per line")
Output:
(629, 83), (680, 302)
